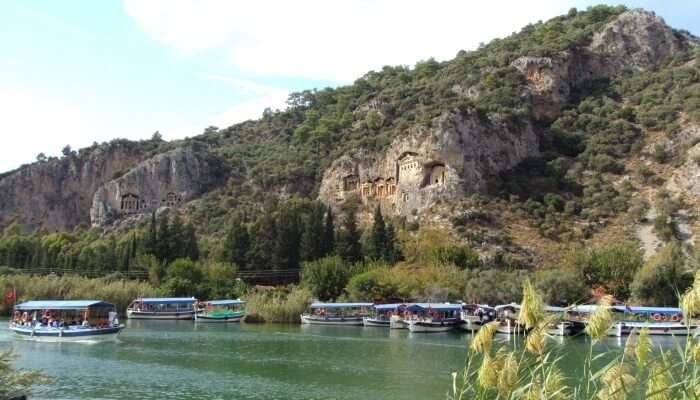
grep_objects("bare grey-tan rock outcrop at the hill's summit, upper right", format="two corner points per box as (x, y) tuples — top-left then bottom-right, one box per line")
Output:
(511, 10), (696, 118)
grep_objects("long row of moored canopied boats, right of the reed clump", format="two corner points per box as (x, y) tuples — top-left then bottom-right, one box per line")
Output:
(301, 303), (699, 337)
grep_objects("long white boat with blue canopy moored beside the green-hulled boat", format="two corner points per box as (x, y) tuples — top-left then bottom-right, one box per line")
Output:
(126, 297), (197, 320)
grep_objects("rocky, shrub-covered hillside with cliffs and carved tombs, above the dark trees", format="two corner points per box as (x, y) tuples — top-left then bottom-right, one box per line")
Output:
(0, 6), (700, 284)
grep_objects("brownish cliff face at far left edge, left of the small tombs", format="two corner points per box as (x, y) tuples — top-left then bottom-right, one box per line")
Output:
(0, 140), (145, 232)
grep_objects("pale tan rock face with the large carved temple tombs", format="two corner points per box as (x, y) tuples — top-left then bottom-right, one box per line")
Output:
(319, 112), (539, 220)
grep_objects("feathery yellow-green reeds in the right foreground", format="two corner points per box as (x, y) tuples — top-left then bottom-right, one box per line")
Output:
(447, 272), (700, 400)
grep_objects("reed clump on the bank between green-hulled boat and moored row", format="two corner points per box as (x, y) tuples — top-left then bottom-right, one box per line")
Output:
(246, 287), (313, 322)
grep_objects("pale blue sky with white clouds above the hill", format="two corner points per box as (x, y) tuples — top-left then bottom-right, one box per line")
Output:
(0, 0), (700, 172)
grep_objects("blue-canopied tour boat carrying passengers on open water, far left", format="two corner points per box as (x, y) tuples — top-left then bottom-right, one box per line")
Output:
(10, 300), (124, 341)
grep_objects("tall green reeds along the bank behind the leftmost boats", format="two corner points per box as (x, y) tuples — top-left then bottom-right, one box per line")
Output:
(0, 274), (165, 315)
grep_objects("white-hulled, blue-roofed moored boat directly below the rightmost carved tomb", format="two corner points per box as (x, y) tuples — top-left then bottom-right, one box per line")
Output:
(406, 303), (462, 333)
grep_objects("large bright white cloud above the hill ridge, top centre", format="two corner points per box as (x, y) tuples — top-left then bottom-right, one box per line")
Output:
(124, 0), (574, 82)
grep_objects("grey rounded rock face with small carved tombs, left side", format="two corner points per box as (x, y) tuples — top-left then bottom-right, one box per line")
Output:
(90, 146), (219, 226)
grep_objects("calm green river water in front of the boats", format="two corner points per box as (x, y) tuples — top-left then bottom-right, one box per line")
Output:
(0, 320), (673, 400)
